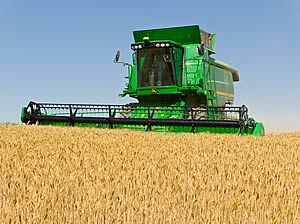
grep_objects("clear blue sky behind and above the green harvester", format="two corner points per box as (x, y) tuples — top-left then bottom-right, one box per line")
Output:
(0, 0), (300, 132)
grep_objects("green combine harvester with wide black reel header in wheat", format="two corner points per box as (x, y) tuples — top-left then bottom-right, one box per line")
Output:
(21, 26), (264, 136)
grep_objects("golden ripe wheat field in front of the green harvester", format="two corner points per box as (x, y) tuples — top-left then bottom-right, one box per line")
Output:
(0, 125), (300, 223)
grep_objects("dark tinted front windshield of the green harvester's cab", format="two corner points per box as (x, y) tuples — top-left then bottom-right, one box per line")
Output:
(137, 47), (176, 87)
